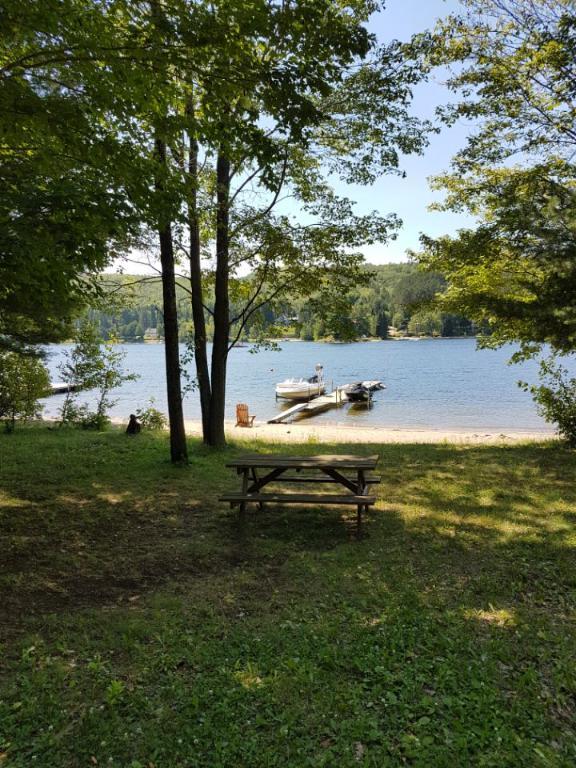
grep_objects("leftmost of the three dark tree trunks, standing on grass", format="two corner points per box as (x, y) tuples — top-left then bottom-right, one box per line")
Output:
(155, 138), (188, 464)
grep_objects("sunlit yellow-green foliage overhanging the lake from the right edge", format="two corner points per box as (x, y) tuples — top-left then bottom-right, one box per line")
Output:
(418, 0), (576, 352)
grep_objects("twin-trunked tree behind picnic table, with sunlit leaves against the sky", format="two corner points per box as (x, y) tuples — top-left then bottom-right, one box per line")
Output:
(177, 2), (432, 445)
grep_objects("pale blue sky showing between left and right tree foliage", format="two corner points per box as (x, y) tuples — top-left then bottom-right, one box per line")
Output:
(354, 0), (470, 264)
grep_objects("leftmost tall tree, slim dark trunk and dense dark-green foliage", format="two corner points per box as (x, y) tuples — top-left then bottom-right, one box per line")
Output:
(0, 0), (195, 461)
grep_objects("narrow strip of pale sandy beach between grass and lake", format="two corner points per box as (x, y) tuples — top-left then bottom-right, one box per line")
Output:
(186, 421), (556, 444)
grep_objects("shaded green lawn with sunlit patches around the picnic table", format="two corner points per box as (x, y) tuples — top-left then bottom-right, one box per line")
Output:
(0, 428), (576, 768)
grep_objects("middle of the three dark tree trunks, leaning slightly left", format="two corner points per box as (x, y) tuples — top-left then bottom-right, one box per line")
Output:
(186, 107), (211, 443)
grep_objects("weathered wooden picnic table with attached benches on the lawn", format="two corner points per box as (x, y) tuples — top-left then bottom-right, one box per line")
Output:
(220, 453), (379, 536)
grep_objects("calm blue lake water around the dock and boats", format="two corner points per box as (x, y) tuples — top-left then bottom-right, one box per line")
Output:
(44, 339), (576, 430)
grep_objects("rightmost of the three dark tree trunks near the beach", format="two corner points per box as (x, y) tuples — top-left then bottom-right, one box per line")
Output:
(206, 151), (230, 447)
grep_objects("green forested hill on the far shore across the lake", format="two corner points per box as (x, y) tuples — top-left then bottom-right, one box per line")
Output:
(90, 264), (476, 341)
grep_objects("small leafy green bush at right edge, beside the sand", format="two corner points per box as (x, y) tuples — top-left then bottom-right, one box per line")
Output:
(521, 355), (576, 448)
